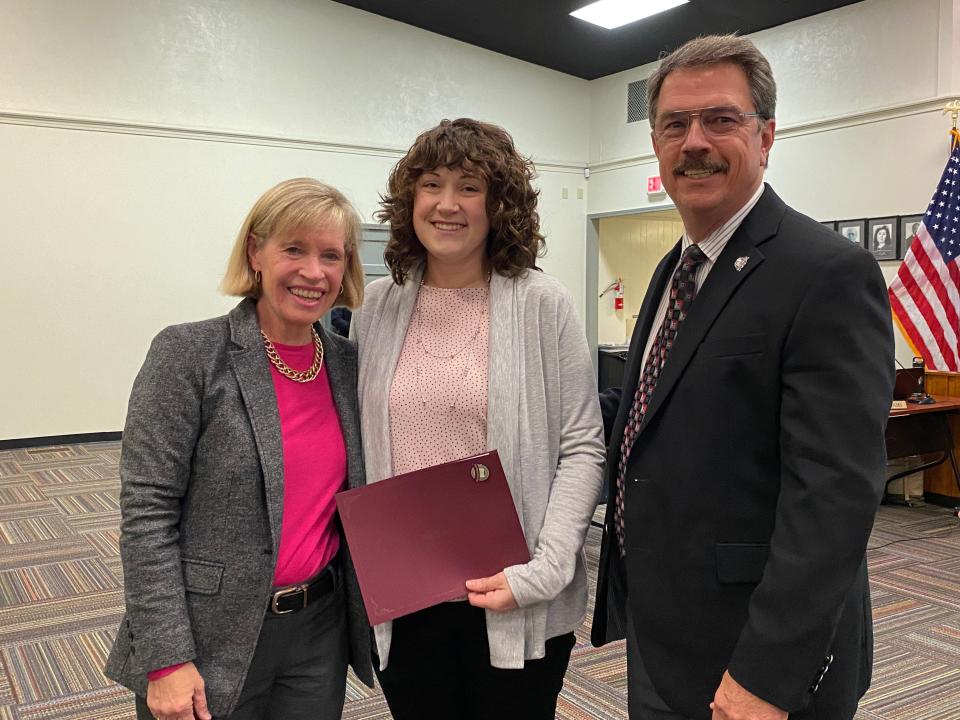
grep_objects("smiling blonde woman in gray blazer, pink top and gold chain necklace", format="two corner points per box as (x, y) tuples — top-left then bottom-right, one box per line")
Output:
(105, 178), (373, 720)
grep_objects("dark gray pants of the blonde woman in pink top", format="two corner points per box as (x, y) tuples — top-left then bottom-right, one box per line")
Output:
(136, 579), (349, 720)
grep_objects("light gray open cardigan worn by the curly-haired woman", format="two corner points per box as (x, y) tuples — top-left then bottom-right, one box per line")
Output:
(351, 271), (604, 668)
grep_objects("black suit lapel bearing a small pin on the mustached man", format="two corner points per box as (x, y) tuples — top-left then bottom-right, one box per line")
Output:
(634, 186), (786, 438)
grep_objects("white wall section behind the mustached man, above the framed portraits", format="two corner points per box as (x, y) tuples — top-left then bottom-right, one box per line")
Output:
(588, 0), (960, 362)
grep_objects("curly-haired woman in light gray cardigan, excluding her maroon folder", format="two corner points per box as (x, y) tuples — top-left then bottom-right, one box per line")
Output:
(352, 119), (604, 720)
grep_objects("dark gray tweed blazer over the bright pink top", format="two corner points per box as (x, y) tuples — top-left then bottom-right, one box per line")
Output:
(105, 300), (373, 716)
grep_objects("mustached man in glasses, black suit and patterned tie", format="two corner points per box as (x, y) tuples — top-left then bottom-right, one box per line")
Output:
(593, 36), (894, 720)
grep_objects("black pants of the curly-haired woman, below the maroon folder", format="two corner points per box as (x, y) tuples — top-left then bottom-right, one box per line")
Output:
(374, 602), (576, 720)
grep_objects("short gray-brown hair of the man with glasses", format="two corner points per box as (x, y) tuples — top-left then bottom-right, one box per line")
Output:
(647, 35), (777, 126)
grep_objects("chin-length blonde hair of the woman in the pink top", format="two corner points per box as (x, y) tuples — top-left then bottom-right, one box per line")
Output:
(220, 178), (364, 308)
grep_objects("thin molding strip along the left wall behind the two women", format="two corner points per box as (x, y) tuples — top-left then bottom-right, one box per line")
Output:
(0, 110), (586, 175)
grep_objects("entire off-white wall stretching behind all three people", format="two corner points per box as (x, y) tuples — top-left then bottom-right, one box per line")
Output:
(7, 0), (960, 439)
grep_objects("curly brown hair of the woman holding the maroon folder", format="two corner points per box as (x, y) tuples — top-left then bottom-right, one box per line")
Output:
(376, 118), (545, 285)
